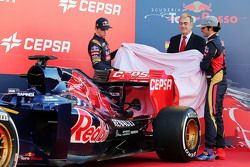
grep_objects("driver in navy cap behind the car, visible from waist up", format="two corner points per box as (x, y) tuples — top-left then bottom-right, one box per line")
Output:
(88, 17), (116, 70)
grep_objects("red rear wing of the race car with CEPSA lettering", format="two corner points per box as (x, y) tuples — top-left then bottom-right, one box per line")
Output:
(109, 70), (179, 117)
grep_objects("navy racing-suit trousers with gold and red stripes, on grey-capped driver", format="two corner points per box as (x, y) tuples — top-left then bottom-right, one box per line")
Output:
(204, 72), (227, 148)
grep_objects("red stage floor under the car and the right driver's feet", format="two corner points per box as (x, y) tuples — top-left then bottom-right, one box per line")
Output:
(81, 148), (250, 167)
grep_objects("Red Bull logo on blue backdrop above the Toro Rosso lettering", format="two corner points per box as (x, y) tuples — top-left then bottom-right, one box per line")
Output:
(183, 1), (212, 13)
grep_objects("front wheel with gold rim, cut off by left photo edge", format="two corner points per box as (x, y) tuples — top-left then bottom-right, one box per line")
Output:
(0, 108), (19, 167)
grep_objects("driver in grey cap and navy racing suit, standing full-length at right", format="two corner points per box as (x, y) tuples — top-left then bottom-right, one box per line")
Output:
(196, 16), (227, 161)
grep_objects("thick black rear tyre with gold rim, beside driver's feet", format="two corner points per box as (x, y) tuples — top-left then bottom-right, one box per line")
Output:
(153, 106), (200, 162)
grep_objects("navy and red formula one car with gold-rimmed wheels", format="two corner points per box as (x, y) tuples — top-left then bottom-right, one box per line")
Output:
(0, 55), (200, 167)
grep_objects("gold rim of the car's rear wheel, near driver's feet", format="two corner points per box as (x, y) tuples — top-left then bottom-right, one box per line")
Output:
(185, 119), (199, 150)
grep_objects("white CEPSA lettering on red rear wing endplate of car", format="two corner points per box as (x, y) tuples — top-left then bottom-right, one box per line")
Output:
(150, 78), (173, 90)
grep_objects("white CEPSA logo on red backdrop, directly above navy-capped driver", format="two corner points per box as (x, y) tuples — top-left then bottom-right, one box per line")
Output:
(58, 0), (122, 16)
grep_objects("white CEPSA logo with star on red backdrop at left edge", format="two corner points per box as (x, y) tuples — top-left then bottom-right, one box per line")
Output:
(0, 32), (70, 53)
